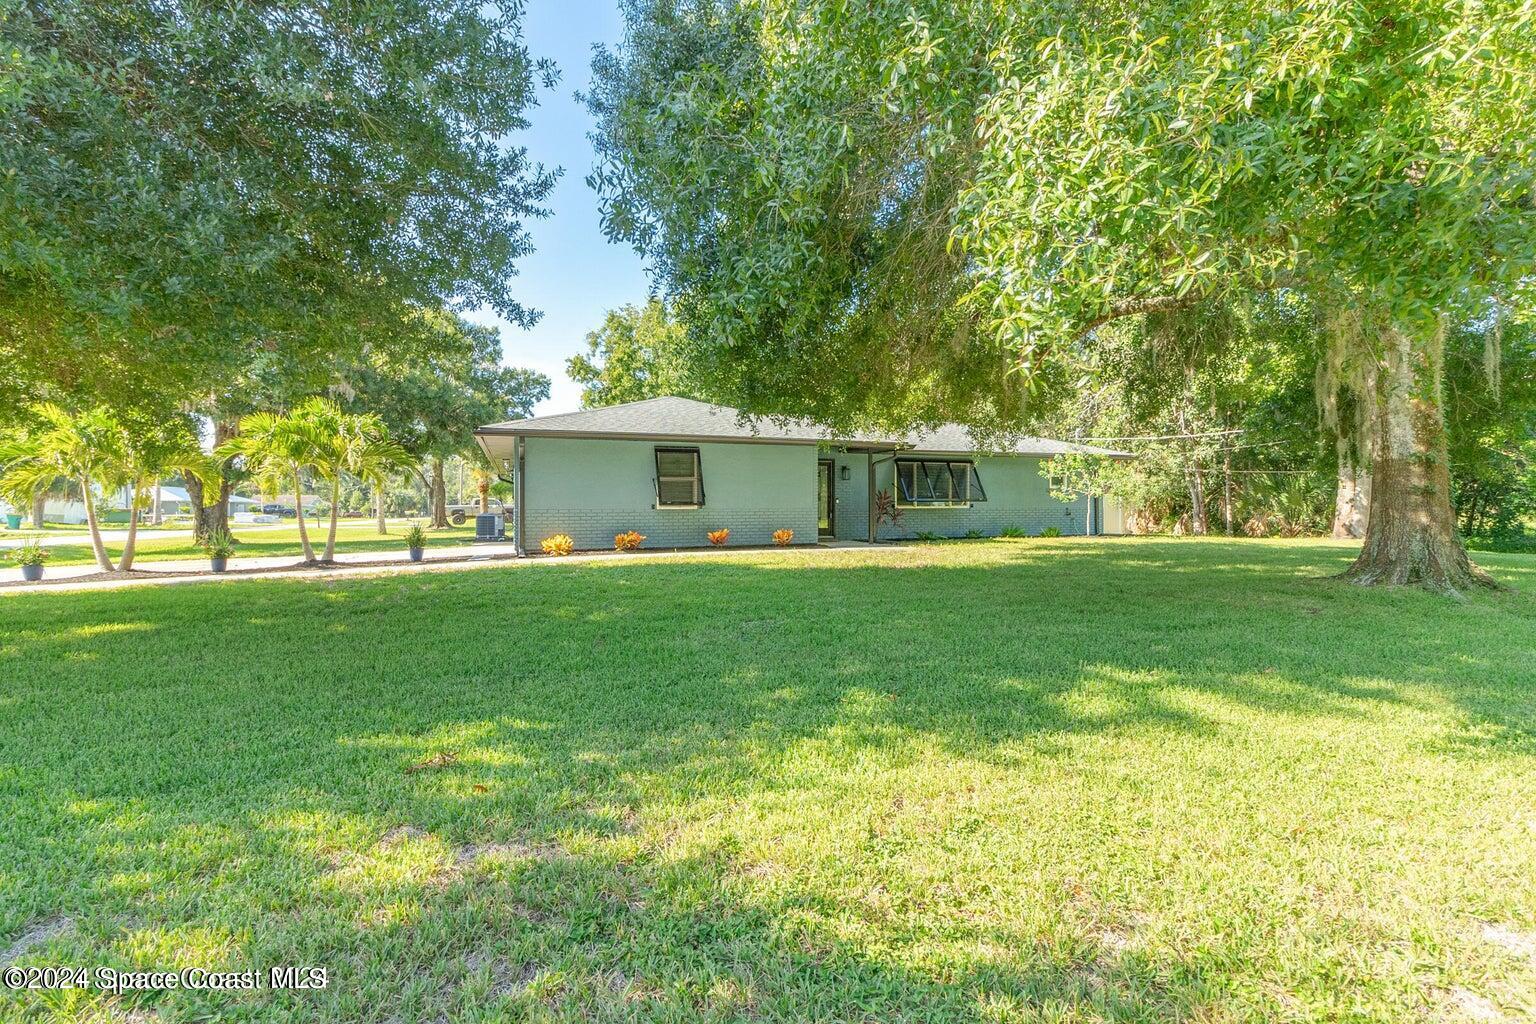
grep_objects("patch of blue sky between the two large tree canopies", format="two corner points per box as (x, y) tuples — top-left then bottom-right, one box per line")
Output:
(470, 0), (650, 415)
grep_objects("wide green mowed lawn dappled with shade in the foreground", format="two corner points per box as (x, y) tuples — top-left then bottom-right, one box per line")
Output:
(0, 539), (1536, 1024)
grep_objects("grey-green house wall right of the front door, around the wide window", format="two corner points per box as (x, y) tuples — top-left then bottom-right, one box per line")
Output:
(876, 451), (1089, 540)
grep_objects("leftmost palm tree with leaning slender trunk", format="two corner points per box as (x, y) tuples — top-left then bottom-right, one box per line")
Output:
(0, 402), (129, 573)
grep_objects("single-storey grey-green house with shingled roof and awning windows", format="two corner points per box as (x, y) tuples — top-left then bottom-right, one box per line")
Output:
(475, 398), (1130, 551)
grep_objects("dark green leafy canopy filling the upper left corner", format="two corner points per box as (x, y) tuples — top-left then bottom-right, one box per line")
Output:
(0, 0), (554, 415)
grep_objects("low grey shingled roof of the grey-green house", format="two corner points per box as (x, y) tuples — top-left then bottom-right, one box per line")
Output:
(475, 396), (1130, 459)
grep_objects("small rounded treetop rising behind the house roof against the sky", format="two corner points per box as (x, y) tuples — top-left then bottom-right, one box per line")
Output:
(565, 299), (707, 408)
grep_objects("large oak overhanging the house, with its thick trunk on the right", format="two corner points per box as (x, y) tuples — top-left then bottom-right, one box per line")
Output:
(588, 0), (1536, 590)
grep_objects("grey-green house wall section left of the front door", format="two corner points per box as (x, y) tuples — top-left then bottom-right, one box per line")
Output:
(522, 436), (817, 553)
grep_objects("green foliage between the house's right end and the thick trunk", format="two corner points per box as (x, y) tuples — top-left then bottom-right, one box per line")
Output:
(1041, 295), (1335, 533)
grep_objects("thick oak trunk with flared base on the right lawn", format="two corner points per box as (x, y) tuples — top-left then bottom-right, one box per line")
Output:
(1344, 320), (1496, 593)
